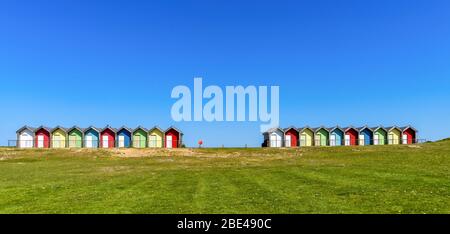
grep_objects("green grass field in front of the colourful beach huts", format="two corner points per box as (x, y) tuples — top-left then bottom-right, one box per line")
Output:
(0, 141), (450, 213)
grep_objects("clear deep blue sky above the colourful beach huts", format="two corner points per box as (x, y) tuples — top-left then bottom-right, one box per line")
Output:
(0, 0), (450, 146)
